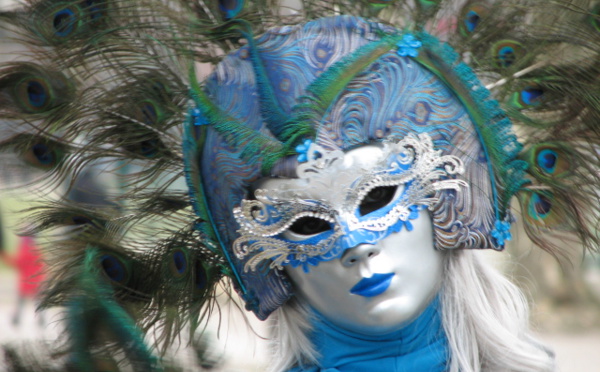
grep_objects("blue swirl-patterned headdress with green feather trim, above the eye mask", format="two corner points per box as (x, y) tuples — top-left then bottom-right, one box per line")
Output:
(184, 16), (526, 319)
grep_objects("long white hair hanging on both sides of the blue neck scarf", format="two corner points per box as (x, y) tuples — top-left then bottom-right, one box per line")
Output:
(271, 250), (555, 372)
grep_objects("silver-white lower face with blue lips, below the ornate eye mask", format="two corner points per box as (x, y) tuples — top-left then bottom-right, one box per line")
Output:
(285, 210), (443, 335)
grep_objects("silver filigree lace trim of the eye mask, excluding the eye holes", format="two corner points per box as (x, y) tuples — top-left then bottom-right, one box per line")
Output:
(233, 134), (468, 271)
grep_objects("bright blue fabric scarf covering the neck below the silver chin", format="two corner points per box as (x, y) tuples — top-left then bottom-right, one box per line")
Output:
(289, 298), (449, 372)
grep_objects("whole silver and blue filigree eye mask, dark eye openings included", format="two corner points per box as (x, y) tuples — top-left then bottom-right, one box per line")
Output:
(234, 134), (467, 271)
